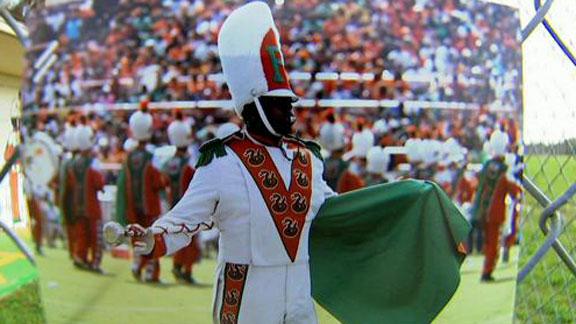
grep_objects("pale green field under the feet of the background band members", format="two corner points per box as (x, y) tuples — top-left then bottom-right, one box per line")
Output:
(32, 243), (516, 324)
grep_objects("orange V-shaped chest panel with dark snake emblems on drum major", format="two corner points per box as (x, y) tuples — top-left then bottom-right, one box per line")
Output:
(228, 139), (312, 262)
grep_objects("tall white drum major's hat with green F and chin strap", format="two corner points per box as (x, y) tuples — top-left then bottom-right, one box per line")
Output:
(218, 1), (298, 134)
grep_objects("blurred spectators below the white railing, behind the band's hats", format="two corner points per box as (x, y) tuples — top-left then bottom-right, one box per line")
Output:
(22, 107), (520, 172)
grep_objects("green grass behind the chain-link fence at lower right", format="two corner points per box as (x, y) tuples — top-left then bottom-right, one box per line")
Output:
(516, 155), (576, 323)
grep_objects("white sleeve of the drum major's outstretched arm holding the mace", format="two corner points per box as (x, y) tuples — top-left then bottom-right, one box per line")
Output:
(151, 162), (220, 254)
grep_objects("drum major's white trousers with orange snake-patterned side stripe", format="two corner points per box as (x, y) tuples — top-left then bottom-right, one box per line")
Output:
(213, 262), (318, 324)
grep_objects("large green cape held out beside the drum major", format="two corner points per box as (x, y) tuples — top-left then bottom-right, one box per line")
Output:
(310, 180), (470, 324)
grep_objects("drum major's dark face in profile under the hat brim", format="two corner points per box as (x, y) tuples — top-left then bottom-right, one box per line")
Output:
(260, 97), (296, 135)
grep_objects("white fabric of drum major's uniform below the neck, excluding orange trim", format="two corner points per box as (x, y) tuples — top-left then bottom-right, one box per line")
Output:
(153, 133), (334, 323)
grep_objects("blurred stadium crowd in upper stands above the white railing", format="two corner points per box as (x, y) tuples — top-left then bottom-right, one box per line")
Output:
(23, 0), (521, 109)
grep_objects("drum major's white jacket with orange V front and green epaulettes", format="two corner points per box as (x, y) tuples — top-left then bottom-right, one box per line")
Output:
(153, 132), (334, 266)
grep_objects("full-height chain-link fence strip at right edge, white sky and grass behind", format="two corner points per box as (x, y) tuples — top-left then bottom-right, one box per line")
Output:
(515, 0), (576, 323)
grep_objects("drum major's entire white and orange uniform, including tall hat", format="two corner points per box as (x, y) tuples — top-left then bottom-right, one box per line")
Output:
(140, 2), (334, 324)
